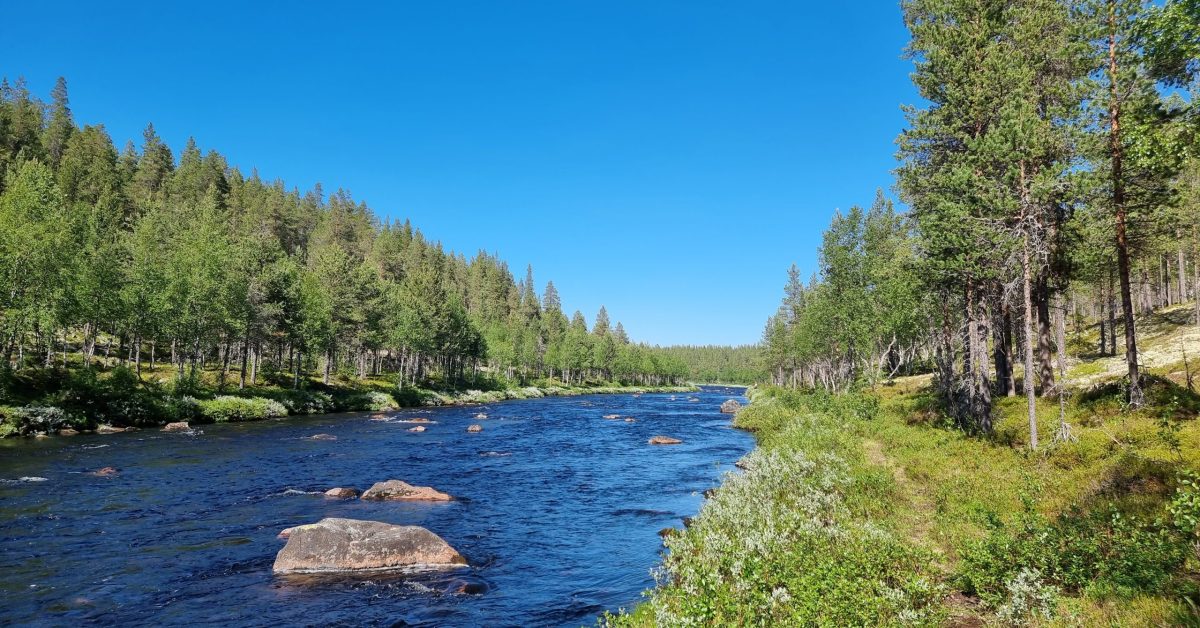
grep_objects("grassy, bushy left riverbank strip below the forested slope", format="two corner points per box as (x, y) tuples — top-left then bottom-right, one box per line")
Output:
(0, 367), (697, 437)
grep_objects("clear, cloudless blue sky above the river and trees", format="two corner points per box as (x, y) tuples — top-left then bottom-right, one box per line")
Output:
(0, 0), (916, 343)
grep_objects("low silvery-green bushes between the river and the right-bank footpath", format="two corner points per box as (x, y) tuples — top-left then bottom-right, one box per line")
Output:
(602, 393), (944, 626)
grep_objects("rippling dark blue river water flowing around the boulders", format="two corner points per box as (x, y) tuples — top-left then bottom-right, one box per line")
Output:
(0, 388), (754, 626)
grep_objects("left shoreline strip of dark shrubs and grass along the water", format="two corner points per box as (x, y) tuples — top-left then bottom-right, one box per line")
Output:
(0, 372), (700, 438)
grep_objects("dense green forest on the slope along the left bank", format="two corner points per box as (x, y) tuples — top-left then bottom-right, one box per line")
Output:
(0, 78), (686, 403)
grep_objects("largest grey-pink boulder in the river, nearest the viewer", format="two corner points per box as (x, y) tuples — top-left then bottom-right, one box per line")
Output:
(271, 518), (467, 574)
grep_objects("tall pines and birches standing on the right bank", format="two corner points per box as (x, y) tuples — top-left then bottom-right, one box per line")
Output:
(763, 0), (1200, 448)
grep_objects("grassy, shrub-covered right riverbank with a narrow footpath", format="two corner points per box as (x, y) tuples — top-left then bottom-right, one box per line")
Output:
(605, 377), (1200, 626)
